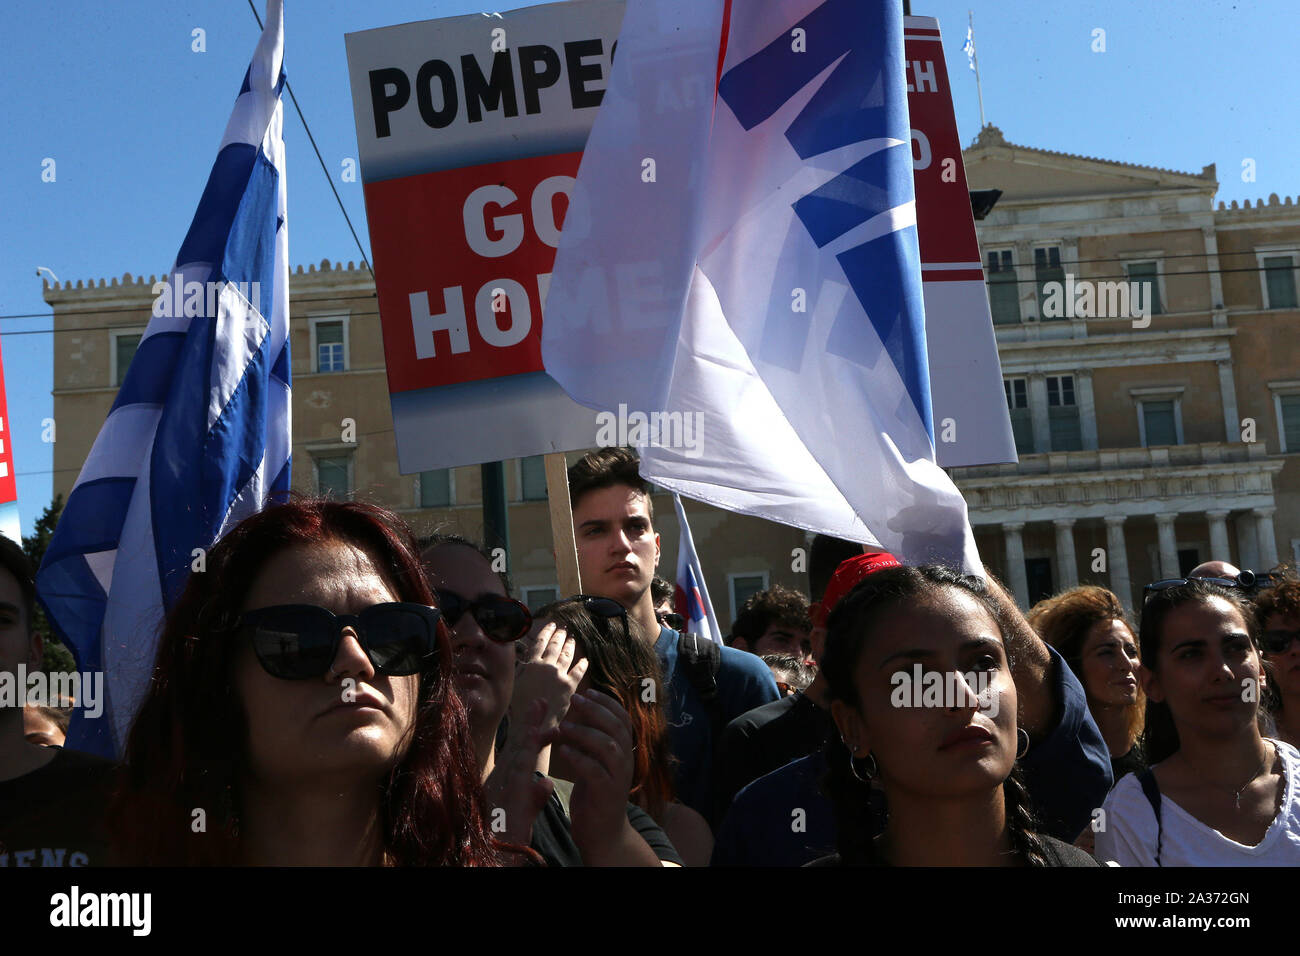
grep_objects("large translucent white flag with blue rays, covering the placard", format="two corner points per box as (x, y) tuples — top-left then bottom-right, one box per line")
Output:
(542, 0), (980, 571)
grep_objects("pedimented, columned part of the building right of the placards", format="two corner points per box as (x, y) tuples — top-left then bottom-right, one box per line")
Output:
(954, 126), (1300, 602)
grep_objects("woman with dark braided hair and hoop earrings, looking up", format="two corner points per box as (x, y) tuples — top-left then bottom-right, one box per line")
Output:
(814, 566), (1097, 866)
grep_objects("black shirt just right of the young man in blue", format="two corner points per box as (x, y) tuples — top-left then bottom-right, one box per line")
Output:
(714, 693), (835, 829)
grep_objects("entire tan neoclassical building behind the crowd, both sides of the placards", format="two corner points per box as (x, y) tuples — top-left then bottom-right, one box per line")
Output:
(44, 126), (1300, 627)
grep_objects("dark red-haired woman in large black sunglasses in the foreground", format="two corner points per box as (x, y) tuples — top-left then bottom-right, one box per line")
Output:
(104, 499), (532, 866)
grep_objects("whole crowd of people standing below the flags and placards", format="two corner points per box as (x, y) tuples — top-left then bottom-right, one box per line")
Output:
(0, 449), (1300, 866)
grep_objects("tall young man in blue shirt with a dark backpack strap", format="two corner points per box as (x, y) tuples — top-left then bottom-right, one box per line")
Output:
(568, 447), (779, 818)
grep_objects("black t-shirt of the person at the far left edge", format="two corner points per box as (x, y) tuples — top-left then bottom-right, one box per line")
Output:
(0, 747), (113, 866)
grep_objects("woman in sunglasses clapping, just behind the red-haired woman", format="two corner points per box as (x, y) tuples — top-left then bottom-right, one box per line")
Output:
(423, 535), (681, 866)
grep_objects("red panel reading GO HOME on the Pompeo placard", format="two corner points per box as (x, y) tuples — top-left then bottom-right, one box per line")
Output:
(365, 152), (582, 392)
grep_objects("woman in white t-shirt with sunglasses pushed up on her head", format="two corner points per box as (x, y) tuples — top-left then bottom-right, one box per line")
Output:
(1097, 579), (1300, 866)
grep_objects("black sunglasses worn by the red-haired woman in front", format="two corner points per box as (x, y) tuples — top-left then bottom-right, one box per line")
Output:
(239, 602), (442, 680)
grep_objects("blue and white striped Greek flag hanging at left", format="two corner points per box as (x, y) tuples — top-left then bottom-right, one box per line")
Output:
(36, 0), (290, 757)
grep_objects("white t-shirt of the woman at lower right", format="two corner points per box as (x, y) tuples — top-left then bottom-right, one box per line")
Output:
(1096, 737), (1300, 866)
